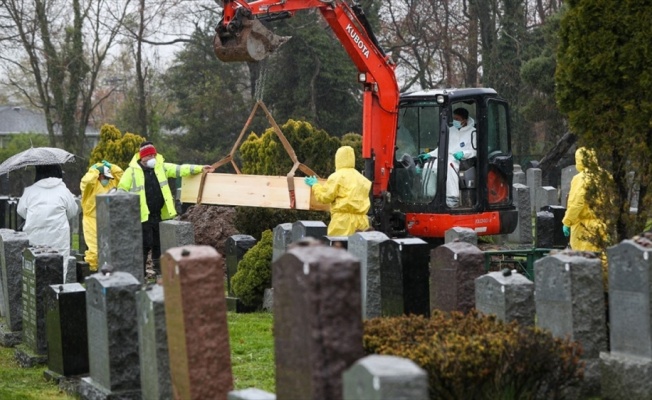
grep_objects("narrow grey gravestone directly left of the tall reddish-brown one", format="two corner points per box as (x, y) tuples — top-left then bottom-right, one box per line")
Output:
(136, 284), (172, 400)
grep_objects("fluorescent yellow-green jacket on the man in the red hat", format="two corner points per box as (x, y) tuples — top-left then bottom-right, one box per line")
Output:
(118, 153), (204, 222)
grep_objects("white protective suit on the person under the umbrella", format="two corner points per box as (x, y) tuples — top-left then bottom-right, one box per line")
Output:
(16, 178), (79, 260)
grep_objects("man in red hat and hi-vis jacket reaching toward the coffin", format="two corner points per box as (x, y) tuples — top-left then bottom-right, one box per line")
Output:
(118, 142), (215, 276)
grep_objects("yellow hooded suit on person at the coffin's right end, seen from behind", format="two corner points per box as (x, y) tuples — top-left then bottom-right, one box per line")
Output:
(312, 146), (371, 236)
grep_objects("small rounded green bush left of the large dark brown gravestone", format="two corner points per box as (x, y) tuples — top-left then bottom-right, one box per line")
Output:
(231, 230), (274, 308)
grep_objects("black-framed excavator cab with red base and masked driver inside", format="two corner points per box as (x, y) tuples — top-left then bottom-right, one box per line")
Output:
(388, 89), (516, 237)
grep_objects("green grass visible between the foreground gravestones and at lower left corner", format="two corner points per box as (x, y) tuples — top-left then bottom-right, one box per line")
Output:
(0, 313), (275, 400)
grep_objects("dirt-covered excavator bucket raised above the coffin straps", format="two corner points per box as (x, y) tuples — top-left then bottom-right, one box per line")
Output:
(213, 19), (291, 62)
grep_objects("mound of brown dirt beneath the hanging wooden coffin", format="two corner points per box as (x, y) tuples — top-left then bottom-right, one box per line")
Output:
(179, 204), (239, 257)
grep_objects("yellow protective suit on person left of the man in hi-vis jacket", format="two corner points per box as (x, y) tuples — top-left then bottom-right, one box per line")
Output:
(79, 163), (122, 271)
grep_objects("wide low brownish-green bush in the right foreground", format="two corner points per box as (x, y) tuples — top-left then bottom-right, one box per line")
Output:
(364, 311), (583, 400)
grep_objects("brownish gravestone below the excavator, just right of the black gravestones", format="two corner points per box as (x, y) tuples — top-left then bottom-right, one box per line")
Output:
(430, 242), (484, 313)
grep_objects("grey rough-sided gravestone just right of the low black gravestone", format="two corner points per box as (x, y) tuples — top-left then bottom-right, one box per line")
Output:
(79, 270), (142, 400)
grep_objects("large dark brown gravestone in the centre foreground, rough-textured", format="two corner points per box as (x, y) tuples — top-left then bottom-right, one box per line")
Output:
(272, 245), (363, 400)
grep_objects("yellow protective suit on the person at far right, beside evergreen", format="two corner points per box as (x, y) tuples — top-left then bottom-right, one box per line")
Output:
(562, 147), (606, 252)
